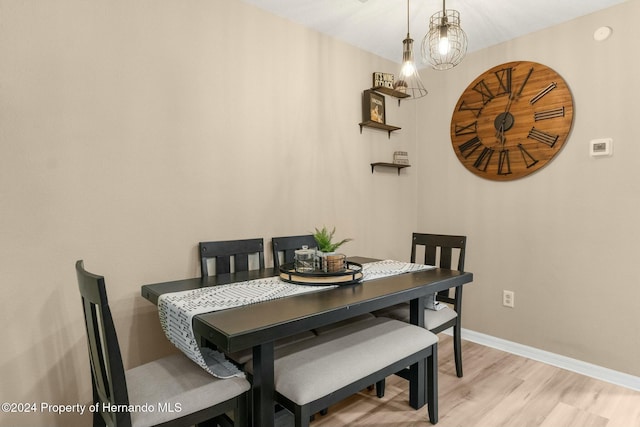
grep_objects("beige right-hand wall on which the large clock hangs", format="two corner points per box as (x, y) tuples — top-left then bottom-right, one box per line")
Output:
(416, 0), (640, 376)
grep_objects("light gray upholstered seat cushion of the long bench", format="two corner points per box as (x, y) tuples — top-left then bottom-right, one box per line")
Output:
(245, 318), (438, 405)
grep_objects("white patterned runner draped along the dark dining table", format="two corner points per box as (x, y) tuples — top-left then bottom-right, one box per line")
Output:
(158, 260), (434, 378)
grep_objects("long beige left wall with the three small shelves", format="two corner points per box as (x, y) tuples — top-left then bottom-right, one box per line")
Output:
(0, 0), (417, 426)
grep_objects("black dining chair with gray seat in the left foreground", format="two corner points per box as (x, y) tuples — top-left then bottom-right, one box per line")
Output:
(76, 260), (251, 427)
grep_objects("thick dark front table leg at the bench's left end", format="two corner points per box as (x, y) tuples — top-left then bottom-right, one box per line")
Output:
(253, 342), (275, 427)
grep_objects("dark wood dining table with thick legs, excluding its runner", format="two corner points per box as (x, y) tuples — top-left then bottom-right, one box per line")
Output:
(141, 256), (473, 427)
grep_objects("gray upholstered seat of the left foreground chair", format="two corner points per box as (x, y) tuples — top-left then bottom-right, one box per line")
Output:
(125, 354), (251, 427)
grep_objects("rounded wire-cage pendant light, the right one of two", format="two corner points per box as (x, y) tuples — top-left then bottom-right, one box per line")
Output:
(422, 0), (467, 70)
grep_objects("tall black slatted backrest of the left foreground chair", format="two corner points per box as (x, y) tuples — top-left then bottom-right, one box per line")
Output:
(76, 260), (131, 426)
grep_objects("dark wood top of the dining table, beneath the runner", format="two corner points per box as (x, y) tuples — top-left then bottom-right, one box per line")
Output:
(142, 257), (473, 352)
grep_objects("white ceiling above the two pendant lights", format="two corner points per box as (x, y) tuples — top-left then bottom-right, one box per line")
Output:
(243, 0), (626, 62)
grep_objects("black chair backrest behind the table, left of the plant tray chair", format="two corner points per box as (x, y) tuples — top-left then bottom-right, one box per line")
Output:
(198, 238), (264, 277)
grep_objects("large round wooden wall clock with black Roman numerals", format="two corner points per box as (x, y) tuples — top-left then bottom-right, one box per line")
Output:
(451, 61), (573, 181)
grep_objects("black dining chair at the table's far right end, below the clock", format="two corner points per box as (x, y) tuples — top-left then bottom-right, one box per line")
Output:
(374, 233), (467, 378)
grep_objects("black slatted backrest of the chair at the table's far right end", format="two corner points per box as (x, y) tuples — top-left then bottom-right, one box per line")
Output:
(411, 233), (467, 304)
